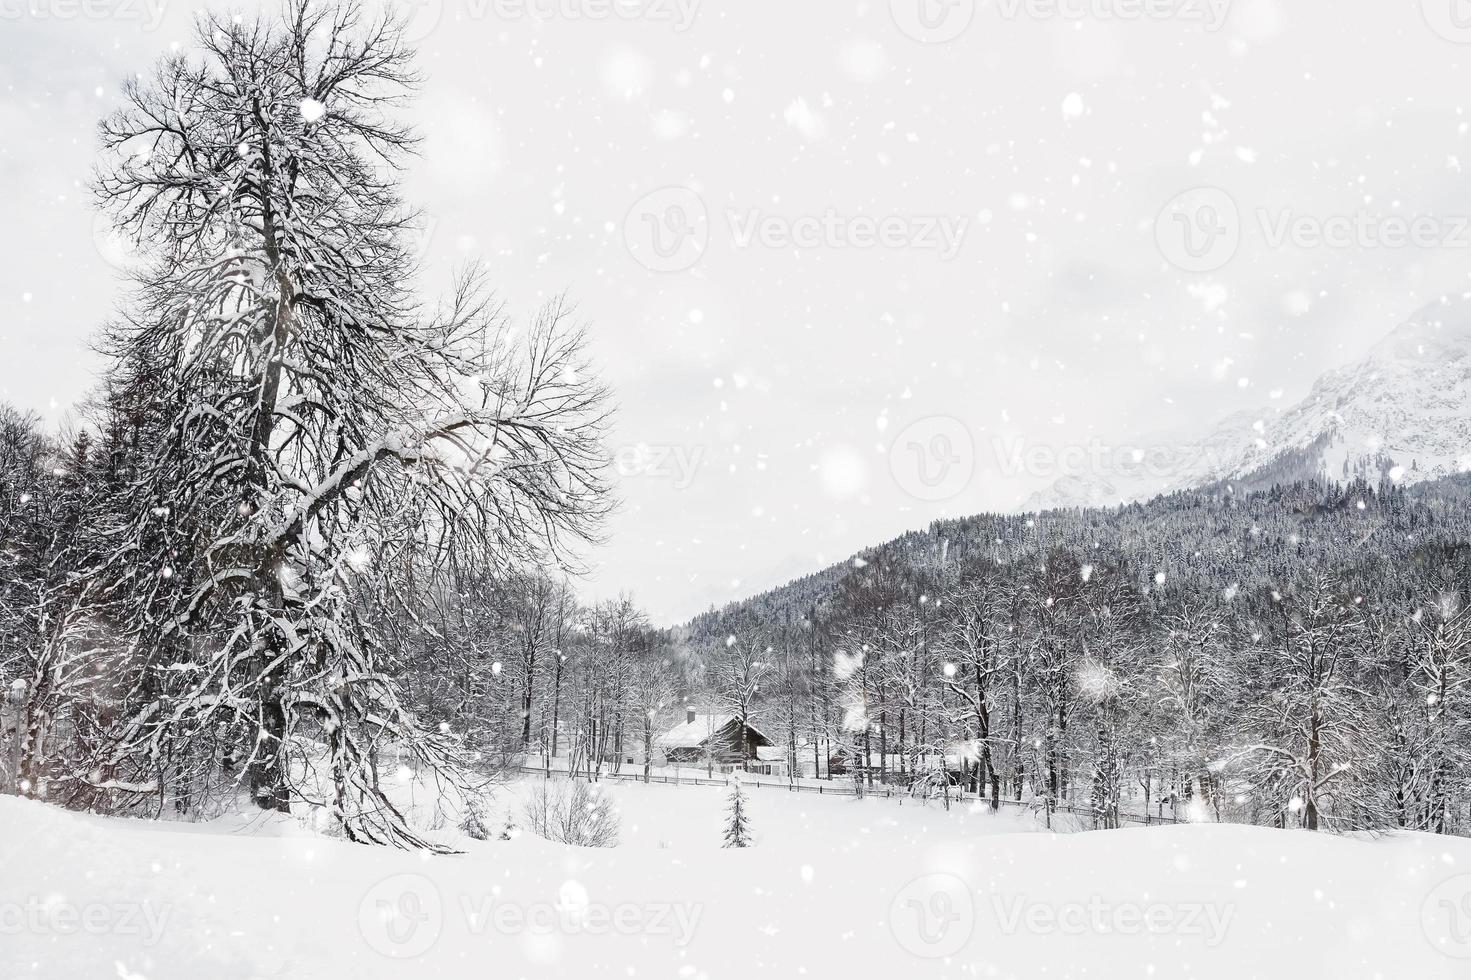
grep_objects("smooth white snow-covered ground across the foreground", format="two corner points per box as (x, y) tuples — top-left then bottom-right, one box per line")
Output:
(0, 778), (1471, 980)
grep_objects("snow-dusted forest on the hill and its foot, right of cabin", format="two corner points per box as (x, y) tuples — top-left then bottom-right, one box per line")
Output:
(691, 477), (1471, 833)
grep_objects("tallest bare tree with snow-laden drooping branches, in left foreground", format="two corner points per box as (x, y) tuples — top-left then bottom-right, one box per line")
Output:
(97, 0), (606, 846)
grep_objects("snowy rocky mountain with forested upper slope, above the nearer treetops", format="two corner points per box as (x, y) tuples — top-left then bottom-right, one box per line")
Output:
(690, 299), (1471, 633)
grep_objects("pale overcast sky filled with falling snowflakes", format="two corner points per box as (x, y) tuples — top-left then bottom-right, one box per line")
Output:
(0, 0), (1471, 622)
